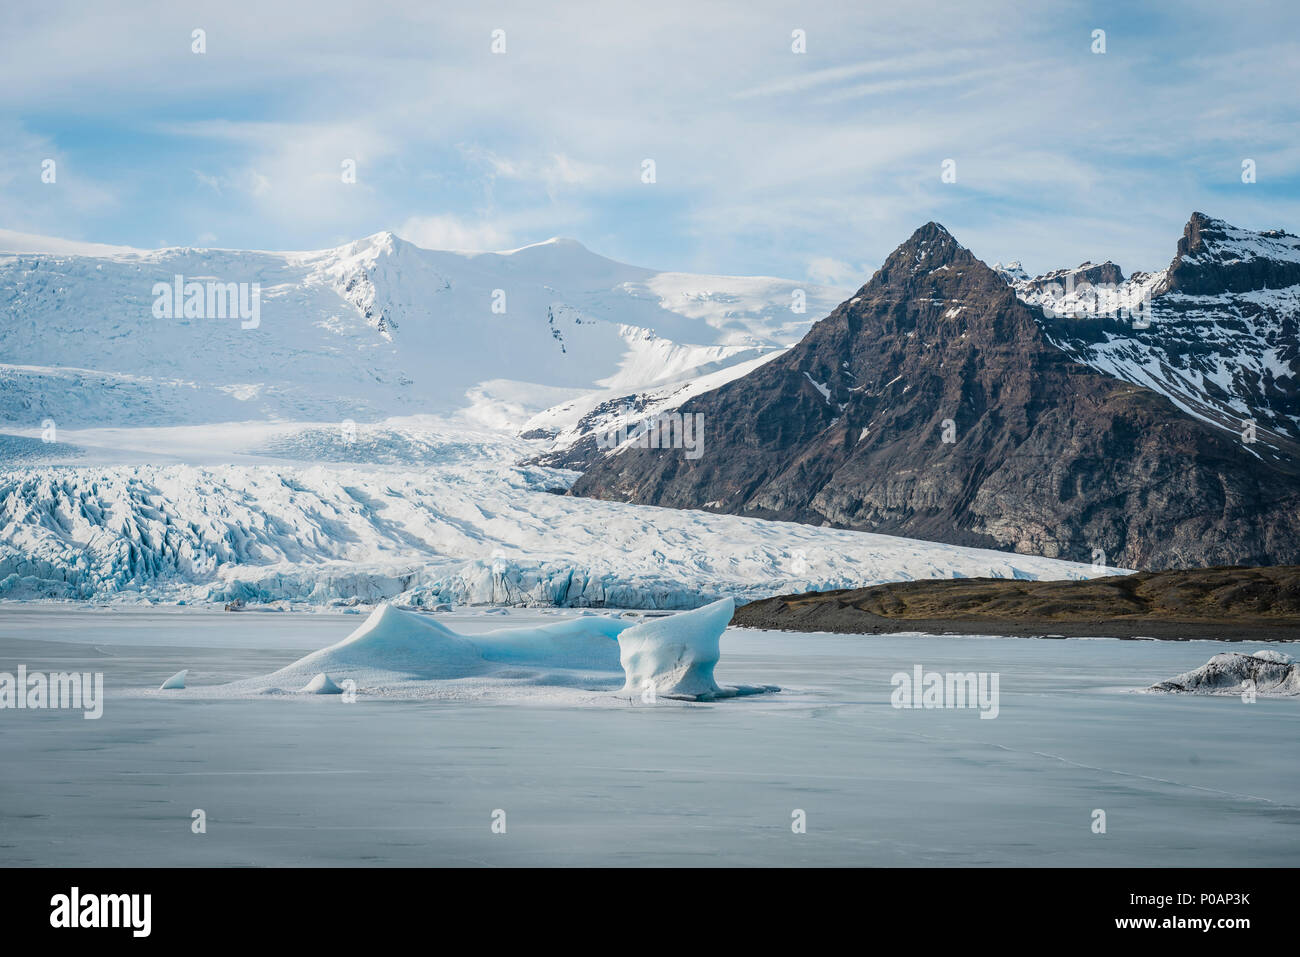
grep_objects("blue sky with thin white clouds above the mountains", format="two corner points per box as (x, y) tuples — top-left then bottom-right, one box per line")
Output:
(0, 0), (1300, 286)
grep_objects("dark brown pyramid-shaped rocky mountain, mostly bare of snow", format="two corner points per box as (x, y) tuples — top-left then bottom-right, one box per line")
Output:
(572, 222), (1300, 568)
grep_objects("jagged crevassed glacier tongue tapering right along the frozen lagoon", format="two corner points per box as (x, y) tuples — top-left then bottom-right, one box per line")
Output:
(0, 463), (1114, 609)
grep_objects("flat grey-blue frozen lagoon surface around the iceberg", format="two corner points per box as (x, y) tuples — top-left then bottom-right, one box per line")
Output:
(0, 605), (1300, 866)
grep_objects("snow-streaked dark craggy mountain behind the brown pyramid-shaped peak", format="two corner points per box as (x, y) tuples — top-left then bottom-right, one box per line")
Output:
(998, 213), (1300, 463)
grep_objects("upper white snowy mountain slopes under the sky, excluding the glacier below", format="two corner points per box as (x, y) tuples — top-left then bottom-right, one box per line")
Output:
(0, 233), (840, 430)
